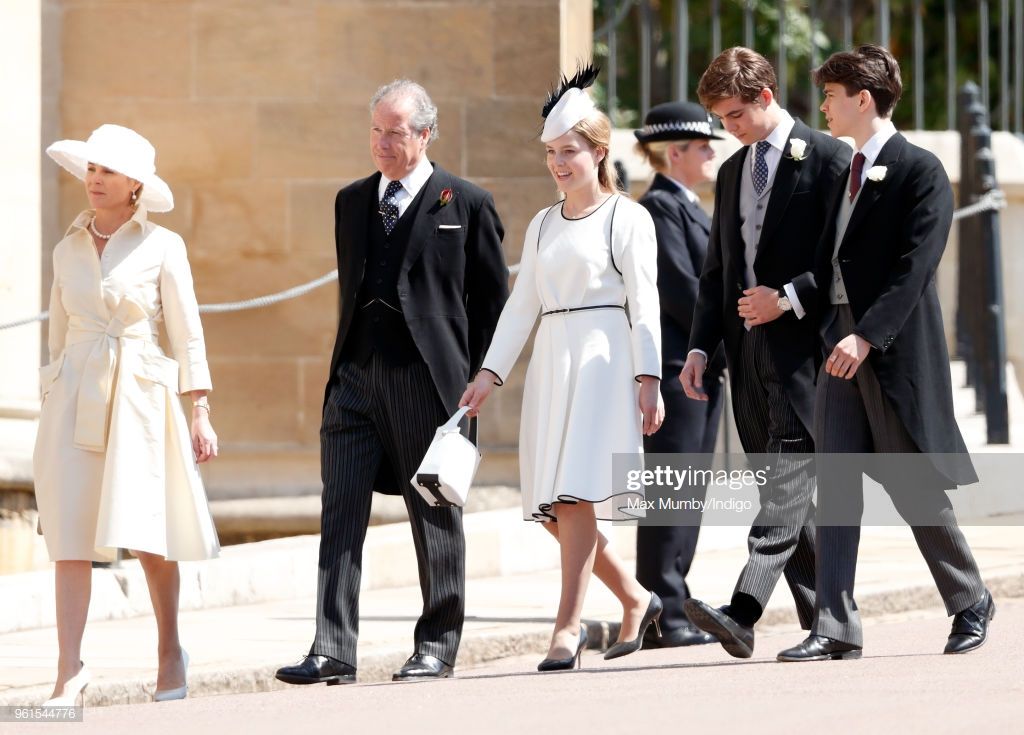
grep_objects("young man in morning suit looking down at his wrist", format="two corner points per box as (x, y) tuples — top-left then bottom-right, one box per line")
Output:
(679, 48), (850, 658)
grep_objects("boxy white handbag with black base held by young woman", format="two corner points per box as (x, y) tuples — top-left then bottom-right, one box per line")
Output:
(410, 406), (480, 508)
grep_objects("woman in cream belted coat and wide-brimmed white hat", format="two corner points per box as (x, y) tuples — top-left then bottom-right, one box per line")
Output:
(33, 125), (219, 704)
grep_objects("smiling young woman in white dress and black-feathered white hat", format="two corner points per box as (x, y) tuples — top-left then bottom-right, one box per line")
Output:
(460, 70), (665, 671)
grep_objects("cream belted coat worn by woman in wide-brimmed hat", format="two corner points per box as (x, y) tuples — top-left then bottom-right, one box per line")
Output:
(33, 208), (219, 561)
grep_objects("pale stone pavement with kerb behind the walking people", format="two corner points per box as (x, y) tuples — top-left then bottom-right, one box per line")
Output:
(0, 510), (1024, 705)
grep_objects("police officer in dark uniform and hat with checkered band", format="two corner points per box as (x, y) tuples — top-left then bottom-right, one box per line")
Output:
(633, 102), (725, 648)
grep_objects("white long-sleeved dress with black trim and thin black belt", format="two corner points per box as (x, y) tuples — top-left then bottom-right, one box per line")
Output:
(483, 194), (662, 521)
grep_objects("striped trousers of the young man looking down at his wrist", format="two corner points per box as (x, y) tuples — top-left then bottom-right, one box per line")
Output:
(733, 327), (814, 630)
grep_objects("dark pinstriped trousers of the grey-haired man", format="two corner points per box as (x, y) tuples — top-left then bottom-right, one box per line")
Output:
(309, 354), (466, 666)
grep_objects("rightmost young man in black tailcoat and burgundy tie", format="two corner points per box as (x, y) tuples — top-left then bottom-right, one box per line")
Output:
(778, 45), (995, 661)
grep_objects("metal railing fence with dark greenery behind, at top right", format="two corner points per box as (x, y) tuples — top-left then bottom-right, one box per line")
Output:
(594, 0), (1024, 133)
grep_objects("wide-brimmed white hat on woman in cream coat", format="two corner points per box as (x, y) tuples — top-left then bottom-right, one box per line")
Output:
(46, 124), (174, 212)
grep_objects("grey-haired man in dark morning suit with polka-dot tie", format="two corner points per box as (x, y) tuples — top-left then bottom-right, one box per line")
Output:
(278, 80), (508, 684)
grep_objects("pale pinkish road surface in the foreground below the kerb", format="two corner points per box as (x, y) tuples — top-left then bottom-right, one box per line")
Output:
(12, 600), (1024, 735)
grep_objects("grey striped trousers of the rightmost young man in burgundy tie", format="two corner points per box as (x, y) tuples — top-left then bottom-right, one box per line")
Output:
(811, 304), (985, 646)
